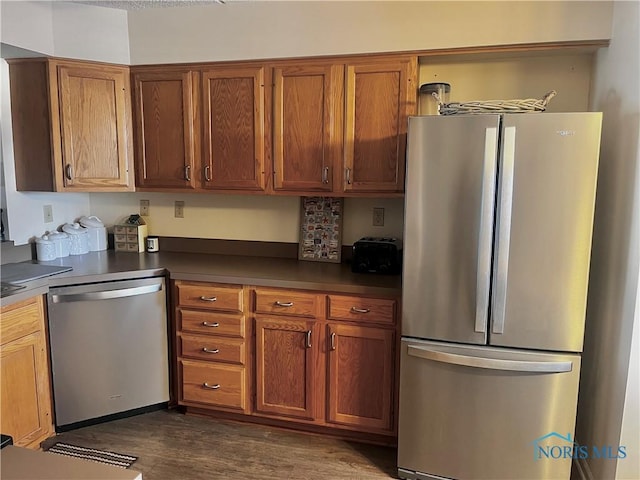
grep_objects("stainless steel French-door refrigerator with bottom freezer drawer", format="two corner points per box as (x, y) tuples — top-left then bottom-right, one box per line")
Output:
(398, 113), (601, 480)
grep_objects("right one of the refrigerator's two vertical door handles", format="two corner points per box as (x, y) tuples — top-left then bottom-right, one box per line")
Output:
(491, 127), (516, 334)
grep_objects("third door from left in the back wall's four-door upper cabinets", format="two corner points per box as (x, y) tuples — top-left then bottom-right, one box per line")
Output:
(273, 64), (343, 192)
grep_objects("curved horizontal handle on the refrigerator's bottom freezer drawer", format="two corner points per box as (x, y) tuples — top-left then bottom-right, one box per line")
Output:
(408, 345), (573, 373)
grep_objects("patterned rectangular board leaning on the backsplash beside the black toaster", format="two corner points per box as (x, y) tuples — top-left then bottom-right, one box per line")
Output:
(298, 197), (343, 263)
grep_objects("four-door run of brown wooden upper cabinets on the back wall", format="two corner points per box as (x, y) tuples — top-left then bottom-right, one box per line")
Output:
(131, 55), (417, 196)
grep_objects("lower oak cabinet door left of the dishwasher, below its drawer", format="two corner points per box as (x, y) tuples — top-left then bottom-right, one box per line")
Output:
(0, 331), (53, 448)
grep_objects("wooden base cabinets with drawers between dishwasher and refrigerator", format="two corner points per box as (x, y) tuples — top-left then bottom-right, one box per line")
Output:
(172, 280), (399, 444)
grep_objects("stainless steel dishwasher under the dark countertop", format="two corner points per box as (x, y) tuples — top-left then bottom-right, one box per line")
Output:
(48, 277), (169, 432)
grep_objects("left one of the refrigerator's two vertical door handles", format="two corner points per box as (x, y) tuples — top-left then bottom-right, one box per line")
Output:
(475, 127), (498, 333)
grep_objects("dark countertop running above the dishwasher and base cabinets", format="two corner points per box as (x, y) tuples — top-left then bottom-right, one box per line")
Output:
(0, 250), (401, 306)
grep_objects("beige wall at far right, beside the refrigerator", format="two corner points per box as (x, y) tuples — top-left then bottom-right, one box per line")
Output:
(576, 2), (640, 479)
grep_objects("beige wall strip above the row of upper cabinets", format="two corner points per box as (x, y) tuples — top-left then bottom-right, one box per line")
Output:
(129, 1), (612, 64)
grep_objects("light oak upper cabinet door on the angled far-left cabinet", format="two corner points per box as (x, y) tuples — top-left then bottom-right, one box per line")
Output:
(54, 63), (133, 191)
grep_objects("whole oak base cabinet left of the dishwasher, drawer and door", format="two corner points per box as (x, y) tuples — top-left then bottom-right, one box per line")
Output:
(0, 296), (54, 448)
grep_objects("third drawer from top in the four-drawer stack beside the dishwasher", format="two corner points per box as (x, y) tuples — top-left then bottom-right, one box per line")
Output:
(180, 335), (245, 365)
